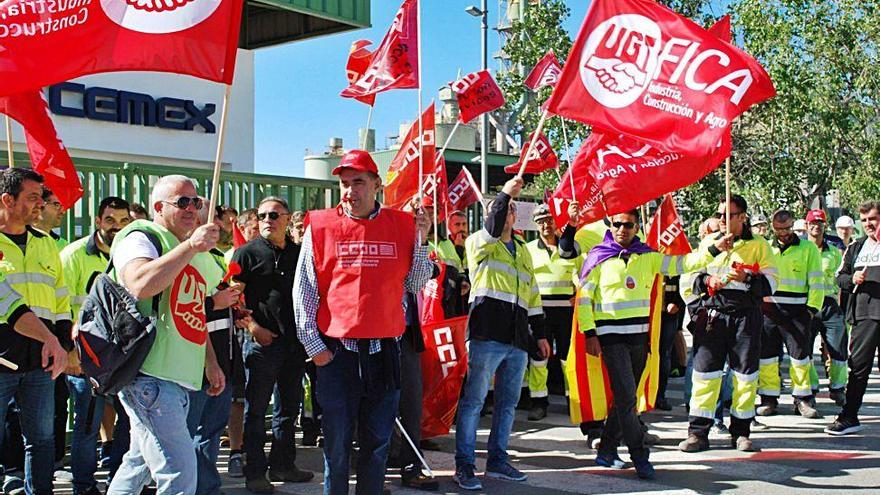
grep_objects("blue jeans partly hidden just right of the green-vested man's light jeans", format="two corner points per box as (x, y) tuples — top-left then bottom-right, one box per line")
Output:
(186, 383), (232, 495)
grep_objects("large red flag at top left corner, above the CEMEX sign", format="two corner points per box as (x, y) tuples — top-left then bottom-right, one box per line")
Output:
(0, 0), (244, 95)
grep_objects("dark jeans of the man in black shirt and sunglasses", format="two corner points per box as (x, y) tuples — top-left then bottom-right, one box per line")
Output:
(244, 339), (305, 479)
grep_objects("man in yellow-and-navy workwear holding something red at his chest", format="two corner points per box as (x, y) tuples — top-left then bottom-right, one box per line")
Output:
(678, 194), (779, 452)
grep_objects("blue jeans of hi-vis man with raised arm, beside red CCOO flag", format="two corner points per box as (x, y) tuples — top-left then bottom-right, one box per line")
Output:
(455, 340), (529, 468)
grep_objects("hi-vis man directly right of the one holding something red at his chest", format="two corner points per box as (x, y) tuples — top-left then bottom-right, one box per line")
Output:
(757, 210), (824, 419)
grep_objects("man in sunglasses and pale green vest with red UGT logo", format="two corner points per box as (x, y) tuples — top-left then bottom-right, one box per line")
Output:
(107, 175), (225, 495)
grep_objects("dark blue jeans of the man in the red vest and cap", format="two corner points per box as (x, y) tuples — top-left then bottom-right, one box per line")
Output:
(315, 346), (398, 495)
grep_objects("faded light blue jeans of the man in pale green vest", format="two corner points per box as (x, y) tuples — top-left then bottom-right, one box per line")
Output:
(107, 375), (197, 495)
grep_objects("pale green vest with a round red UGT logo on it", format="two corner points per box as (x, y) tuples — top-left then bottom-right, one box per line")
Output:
(110, 220), (216, 390)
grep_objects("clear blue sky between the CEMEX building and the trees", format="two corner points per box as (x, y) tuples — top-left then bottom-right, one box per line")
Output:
(255, 0), (589, 176)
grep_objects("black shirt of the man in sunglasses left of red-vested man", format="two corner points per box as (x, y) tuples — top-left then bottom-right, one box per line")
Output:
(232, 237), (304, 352)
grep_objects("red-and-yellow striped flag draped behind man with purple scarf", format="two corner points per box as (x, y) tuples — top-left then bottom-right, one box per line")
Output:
(565, 275), (663, 424)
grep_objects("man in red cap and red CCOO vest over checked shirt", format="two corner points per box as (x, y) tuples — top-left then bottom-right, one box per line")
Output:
(293, 150), (434, 495)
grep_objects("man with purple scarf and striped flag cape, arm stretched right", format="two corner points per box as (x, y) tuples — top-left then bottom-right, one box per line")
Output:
(577, 210), (732, 479)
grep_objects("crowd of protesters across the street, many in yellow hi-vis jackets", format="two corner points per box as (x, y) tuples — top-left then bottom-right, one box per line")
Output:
(0, 150), (880, 495)
